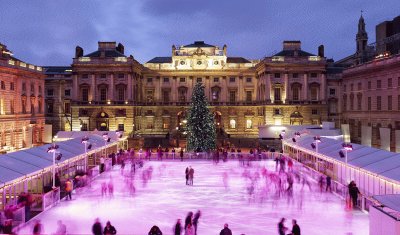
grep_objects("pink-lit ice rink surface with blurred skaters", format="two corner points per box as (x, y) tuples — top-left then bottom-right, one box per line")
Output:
(18, 160), (369, 235)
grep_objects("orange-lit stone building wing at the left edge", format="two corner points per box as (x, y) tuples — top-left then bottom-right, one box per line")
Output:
(0, 44), (45, 152)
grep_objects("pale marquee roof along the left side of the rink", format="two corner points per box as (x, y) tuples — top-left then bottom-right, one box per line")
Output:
(0, 134), (117, 184)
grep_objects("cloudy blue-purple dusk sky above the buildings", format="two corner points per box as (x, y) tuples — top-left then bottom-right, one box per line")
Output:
(0, 0), (400, 65)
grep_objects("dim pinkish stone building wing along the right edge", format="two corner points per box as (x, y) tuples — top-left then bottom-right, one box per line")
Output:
(343, 54), (400, 151)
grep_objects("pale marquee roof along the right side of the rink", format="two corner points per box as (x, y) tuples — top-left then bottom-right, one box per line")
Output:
(287, 135), (400, 182)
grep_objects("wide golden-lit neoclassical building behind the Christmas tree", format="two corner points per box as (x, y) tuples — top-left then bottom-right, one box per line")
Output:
(45, 41), (328, 147)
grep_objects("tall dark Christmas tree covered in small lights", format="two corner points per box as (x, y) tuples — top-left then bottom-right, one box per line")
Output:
(187, 83), (216, 152)
